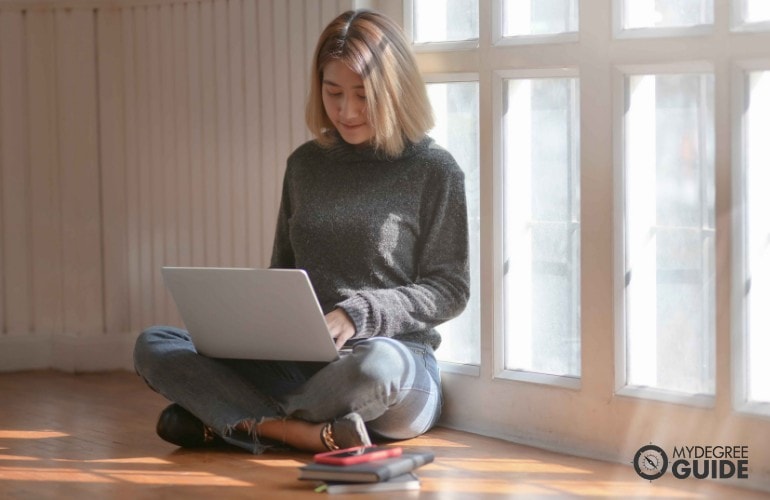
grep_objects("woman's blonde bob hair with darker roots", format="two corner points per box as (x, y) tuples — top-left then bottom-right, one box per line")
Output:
(305, 9), (433, 157)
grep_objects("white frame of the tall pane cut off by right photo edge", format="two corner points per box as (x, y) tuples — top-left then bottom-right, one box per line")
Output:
(731, 59), (770, 418)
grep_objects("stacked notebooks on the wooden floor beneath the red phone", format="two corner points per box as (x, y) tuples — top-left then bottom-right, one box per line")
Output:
(299, 450), (434, 494)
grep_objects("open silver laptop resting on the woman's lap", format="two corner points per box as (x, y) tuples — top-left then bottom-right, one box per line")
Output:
(161, 267), (339, 362)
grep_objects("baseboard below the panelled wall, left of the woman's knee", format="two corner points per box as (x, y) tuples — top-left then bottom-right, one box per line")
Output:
(0, 333), (136, 373)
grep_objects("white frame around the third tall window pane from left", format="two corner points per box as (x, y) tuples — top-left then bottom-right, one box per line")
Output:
(612, 61), (716, 408)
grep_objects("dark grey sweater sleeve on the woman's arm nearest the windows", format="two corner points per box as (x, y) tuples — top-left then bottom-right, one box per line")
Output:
(337, 161), (470, 338)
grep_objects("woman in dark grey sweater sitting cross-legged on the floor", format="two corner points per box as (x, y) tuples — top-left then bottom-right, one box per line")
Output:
(134, 10), (469, 453)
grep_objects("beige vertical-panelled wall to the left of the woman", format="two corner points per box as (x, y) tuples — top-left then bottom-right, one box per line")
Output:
(0, 0), (353, 371)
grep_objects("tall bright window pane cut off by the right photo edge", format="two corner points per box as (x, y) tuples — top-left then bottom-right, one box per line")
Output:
(744, 71), (770, 402)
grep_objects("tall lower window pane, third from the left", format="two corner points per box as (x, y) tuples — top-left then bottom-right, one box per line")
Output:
(624, 74), (715, 394)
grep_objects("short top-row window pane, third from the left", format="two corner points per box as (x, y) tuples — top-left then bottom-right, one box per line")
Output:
(622, 0), (714, 29)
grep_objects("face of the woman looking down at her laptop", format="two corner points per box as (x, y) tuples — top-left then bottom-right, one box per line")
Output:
(321, 61), (374, 144)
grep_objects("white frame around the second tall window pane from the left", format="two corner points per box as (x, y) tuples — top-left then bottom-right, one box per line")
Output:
(492, 67), (582, 390)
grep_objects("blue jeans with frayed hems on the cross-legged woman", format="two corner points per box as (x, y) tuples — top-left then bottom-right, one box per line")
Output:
(134, 326), (442, 453)
